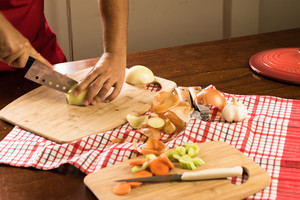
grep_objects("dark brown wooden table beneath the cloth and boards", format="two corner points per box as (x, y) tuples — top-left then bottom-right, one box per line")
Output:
(0, 28), (300, 200)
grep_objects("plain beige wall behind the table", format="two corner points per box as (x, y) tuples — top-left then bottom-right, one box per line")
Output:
(45, 0), (300, 60)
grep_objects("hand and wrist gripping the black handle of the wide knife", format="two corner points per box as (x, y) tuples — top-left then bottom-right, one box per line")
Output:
(0, 13), (53, 69)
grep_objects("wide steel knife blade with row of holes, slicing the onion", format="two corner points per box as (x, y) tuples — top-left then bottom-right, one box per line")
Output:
(25, 57), (78, 93)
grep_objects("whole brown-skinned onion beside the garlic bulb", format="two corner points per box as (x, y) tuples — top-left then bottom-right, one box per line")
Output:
(194, 88), (227, 110)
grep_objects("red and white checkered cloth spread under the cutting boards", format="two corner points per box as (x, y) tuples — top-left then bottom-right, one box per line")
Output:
(0, 85), (300, 199)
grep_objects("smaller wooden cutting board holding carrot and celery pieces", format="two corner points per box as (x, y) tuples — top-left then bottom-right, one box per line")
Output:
(84, 141), (271, 200)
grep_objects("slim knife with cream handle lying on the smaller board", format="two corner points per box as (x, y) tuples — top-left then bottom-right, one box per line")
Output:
(117, 166), (243, 183)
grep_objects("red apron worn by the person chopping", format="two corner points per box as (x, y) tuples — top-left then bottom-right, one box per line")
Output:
(0, 0), (66, 71)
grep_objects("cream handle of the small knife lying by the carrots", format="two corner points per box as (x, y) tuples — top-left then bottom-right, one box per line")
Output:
(181, 166), (243, 181)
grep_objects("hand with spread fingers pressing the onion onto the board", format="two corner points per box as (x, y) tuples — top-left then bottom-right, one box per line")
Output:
(73, 52), (126, 106)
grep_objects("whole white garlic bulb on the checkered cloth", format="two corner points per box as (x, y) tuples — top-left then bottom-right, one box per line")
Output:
(222, 97), (248, 122)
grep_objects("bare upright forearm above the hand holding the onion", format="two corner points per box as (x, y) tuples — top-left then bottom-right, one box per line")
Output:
(98, 0), (128, 54)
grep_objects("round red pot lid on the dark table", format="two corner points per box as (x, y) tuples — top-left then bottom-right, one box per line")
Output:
(249, 48), (300, 84)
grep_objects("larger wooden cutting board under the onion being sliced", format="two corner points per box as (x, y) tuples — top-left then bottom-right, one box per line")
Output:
(0, 68), (176, 143)
